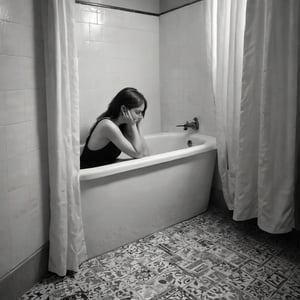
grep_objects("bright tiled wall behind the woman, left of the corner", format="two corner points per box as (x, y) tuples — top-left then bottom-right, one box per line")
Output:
(76, 4), (161, 142)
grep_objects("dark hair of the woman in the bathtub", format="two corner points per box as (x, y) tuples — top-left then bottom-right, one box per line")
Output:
(97, 87), (147, 120)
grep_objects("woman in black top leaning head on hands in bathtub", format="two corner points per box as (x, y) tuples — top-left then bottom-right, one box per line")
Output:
(80, 88), (148, 169)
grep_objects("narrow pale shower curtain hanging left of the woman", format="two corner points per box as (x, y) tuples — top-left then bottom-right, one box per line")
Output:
(42, 0), (87, 276)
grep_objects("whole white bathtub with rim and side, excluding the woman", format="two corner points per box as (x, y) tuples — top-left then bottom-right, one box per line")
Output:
(80, 133), (216, 258)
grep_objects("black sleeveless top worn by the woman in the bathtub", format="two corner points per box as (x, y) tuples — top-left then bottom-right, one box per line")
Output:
(80, 119), (121, 169)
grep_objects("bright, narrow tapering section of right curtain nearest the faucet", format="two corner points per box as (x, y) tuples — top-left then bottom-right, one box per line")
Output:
(204, 0), (247, 209)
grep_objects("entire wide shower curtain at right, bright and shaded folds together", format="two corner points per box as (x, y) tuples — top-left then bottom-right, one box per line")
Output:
(204, 0), (299, 233)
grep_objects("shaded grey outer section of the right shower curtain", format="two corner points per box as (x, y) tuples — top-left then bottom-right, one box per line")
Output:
(234, 0), (299, 233)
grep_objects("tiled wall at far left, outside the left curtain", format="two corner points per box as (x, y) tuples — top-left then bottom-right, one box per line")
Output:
(0, 0), (49, 278)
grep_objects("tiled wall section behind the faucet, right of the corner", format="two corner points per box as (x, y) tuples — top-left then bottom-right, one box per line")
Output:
(159, 1), (215, 135)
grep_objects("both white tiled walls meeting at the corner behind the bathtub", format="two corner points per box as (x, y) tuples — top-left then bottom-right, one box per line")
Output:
(77, 2), (215, 141)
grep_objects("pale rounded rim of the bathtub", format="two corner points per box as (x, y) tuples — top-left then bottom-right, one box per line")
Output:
(79, 132), (216, 181)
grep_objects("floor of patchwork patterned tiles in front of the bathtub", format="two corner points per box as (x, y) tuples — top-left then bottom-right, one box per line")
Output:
(21, 208), (300, 300)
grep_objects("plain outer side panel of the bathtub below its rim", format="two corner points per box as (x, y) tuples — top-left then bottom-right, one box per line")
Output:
(81, 151), (216, 257)
